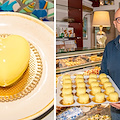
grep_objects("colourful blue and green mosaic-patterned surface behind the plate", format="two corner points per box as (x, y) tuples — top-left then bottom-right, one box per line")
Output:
(0, 0), (54, 21)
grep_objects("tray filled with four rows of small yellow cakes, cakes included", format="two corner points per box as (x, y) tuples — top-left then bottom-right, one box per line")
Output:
(56, 73), (120, 107)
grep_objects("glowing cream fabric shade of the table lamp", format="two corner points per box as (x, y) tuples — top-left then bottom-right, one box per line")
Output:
(93, 11), (110, 27)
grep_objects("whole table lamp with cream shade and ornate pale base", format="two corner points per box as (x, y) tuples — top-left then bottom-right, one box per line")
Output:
(93, 11), (110, 47)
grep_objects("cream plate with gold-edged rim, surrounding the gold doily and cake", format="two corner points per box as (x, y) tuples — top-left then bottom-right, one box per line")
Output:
(0, 12), (54, 120)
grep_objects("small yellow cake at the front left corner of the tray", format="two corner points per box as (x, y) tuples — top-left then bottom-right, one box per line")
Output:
(63, 94), (74, 105)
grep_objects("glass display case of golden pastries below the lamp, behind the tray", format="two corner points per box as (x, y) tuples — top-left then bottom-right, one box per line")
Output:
(56, 48), (104, 74)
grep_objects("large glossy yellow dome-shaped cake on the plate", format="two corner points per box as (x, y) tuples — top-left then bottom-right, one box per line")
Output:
(0, 35), (30, 87)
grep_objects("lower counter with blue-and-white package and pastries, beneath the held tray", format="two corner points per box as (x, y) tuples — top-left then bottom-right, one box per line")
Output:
(56, 104), (111, 120)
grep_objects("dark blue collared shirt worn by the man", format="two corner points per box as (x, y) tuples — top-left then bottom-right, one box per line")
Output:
(100, 36), (120, 89)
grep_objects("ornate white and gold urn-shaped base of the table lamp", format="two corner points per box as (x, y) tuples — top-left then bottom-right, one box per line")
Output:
(96, 31), (107, 48)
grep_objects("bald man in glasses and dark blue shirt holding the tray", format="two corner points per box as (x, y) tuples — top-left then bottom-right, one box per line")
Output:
(100, 9), (120, 120)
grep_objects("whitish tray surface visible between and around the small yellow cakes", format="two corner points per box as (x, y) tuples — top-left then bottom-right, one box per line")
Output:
(56, 75), (120, 107)
